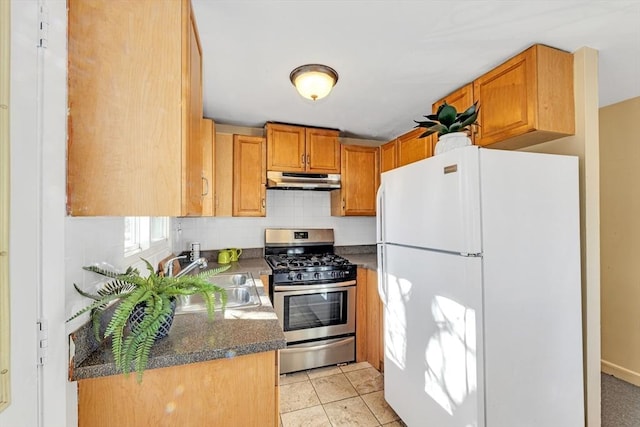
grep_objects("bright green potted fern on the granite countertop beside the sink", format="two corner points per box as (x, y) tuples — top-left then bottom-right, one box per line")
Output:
(67, 259), (230, 382)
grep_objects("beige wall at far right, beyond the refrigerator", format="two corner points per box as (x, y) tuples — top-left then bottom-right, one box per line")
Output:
(600, 97), (640, 386)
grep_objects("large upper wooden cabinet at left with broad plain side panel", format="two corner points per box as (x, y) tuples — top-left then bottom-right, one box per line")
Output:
(67, 0), (203, 216)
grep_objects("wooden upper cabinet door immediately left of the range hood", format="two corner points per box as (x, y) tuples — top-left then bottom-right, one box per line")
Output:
(233, 135), (267, 216)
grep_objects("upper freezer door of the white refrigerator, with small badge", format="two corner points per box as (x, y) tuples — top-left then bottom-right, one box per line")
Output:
(378, 146), (482, 253)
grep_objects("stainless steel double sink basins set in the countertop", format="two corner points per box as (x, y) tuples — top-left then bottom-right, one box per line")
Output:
(176, 273), (262, 314)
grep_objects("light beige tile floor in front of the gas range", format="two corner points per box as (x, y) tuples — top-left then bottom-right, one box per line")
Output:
(280, 362), (406, 427)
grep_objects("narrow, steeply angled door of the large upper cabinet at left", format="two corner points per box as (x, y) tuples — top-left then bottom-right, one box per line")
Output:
(182, 5), (203, 216)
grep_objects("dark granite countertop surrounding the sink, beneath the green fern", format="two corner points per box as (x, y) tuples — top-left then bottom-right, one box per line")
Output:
(69, 276), (286, 381)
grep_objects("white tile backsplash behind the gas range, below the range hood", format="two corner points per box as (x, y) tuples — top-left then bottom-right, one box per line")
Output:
(171, 190), (376, 252)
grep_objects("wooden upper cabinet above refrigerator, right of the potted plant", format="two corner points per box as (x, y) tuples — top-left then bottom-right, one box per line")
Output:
(473, 45), (575, 149)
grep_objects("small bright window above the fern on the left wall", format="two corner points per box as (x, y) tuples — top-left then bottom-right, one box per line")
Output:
(124, 216), (169, 257)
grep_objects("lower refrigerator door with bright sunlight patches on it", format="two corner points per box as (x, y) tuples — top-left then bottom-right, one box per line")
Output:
(379, 245), (484, 427)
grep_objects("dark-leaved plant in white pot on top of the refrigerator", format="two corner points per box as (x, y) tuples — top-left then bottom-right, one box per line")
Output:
(414, 101), (480, 154)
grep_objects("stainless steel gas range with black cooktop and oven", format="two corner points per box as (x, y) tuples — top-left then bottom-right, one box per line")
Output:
(265, 228), (357, 373)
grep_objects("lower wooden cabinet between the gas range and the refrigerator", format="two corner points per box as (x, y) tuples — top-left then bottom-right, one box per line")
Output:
(356, 268), (384, 372)
